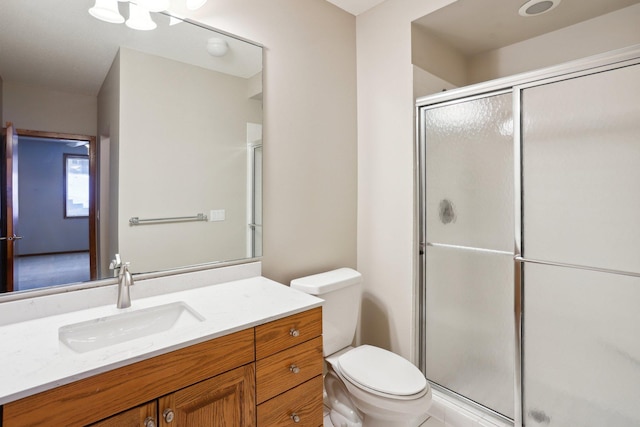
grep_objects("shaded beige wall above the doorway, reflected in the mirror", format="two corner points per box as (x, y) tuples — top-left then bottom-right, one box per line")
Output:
(3, 81), (97, 135)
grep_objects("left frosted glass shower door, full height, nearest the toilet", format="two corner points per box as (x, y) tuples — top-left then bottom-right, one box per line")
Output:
(420, 93), (515, 418)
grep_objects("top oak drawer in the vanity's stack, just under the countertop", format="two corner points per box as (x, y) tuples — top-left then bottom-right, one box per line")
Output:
(256, 307), (322, 359)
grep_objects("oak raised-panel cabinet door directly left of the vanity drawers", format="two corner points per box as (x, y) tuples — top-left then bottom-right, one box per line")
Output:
(159, 364), (256, 427)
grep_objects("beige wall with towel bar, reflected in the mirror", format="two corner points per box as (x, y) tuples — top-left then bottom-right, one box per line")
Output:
(118, 48), (250, 272)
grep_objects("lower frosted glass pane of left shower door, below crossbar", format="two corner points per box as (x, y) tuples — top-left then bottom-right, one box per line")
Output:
(425, 247), (515, 418)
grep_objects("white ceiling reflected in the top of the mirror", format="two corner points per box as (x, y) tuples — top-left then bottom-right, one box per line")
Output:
(0, 0), (262, 95)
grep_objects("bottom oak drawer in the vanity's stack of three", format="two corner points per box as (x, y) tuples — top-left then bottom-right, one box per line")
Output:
(258, 375), (322, 427)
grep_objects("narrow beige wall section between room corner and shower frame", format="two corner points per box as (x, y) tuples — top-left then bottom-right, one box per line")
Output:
(357, 0), (452, 360)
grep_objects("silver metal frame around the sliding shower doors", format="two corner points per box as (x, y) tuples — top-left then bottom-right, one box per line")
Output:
(414, 45), (640, 427)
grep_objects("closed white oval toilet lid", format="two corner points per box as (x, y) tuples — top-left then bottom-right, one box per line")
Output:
(337, 345), (427, 396)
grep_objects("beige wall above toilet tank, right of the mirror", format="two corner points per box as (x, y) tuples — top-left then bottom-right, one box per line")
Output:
(186, 0), (357, 284)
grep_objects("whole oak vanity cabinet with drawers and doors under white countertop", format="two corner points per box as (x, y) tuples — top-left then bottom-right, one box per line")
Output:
(0, 307), (323, 427)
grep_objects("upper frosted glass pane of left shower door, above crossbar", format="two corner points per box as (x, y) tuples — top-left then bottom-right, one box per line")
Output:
(424, 94), (514, 251)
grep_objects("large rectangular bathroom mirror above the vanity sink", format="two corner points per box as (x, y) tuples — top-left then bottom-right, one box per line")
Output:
(0, 0), (262, 300)
